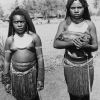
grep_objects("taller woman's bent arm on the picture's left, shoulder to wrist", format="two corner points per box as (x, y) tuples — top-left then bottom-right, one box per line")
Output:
(53, 21), (73, 49)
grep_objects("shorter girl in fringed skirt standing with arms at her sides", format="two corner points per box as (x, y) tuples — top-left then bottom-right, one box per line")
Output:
(3, 7), (44, 100)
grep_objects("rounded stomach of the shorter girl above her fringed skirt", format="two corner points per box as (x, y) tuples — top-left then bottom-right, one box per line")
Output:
(12, 50), (37, 72)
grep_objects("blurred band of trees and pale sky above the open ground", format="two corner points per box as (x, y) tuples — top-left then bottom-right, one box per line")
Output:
(0, 0), (100, 23)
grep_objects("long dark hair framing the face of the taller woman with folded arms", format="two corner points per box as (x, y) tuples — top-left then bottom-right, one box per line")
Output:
(65, 0), (91, 20)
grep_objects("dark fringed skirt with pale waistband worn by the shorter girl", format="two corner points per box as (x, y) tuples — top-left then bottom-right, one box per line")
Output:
(11, 62), (37, 100)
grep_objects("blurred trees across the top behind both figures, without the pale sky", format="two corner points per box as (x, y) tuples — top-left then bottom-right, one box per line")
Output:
(0, 0), (100, 22)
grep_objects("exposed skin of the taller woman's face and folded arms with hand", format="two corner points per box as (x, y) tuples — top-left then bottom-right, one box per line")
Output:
(54, 1), (98, 52)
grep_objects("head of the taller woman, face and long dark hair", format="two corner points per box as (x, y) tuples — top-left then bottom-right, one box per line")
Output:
(66, 0), (90, 20)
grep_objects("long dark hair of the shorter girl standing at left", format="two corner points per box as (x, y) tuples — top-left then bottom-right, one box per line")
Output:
(8, 7), (36, 37)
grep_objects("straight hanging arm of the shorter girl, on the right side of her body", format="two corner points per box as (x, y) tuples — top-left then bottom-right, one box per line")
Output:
(35, 34), (44, 90)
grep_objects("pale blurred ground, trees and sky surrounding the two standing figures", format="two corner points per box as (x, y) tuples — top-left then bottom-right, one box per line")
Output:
(0, 0), (100, 100)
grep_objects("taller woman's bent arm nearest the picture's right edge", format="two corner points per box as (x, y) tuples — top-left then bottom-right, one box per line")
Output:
(82, 21), (98, 52)
